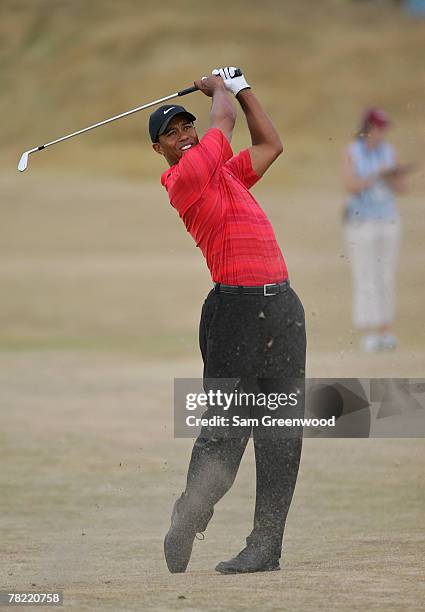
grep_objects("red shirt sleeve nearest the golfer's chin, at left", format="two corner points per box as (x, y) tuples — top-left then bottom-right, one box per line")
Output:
(163, 128), (233, 216)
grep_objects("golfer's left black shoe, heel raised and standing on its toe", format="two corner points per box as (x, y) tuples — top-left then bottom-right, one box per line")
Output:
(164, 493), (213, 574)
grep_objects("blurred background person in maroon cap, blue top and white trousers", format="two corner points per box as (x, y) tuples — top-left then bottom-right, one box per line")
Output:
(343, 108), (408, 352)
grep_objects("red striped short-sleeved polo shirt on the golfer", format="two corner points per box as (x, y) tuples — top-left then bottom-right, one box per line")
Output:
(161, 128), (288, 285)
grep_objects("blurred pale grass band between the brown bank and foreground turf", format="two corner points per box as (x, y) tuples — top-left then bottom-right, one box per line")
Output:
(0, 172), (425, 358)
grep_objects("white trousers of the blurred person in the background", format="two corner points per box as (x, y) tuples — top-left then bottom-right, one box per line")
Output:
(344, 219), (400, 329)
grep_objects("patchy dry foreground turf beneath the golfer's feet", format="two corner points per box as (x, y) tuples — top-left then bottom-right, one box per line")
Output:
(0, 351), (425, 612)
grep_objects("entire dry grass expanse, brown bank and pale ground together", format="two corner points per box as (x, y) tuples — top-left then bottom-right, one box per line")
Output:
(0, 0), (425, 612)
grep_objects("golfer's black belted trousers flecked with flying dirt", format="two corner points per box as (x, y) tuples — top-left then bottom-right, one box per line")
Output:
(184, 288), (306, 558)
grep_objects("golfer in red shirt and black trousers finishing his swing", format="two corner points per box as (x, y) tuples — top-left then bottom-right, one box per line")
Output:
(149, 67), (306, 573)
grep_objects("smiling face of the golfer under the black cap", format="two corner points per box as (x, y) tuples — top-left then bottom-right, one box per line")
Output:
(152, 115), (199, 166)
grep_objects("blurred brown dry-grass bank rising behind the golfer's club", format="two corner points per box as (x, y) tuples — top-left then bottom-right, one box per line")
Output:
(0, 0), (425, 184)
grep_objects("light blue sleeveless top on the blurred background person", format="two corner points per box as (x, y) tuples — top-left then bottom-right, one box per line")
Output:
(345, 138), (398, 222)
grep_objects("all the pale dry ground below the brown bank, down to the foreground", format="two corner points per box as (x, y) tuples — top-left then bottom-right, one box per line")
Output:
(0, 173), (425, 612)
